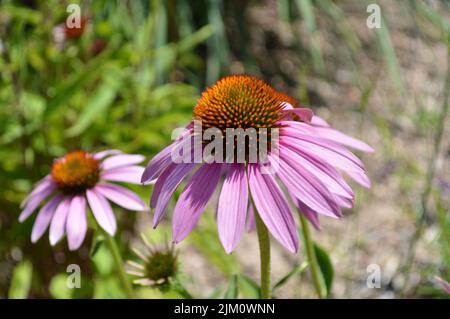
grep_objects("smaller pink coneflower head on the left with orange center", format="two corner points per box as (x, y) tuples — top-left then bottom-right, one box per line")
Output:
(19, 150), (146, 250)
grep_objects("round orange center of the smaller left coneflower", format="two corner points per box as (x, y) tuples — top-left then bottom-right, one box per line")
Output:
(51, 151), (100, 193)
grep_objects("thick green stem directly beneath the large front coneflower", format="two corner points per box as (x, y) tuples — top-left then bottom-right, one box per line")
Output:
(253, 211), (271, 299)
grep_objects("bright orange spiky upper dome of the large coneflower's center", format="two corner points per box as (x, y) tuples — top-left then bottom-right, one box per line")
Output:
(194, 75), (286, 132)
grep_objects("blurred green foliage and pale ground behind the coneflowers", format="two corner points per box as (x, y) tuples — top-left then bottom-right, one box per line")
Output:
(0, 0), (450, 298)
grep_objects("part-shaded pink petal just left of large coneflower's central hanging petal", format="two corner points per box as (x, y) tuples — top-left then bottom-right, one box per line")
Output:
(172, 163), (222, 243)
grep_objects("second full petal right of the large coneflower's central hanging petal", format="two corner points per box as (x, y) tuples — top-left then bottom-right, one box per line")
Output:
(270, 149), (341, 217)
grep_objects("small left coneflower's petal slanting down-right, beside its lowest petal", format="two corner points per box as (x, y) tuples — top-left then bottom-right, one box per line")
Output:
(86, 188), (117, 235)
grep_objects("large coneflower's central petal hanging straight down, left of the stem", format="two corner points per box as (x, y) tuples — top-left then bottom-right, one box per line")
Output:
(217, 164), (248, 253)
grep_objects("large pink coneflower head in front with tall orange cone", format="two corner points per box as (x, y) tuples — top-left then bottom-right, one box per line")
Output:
(142, 75), (373, 252)
